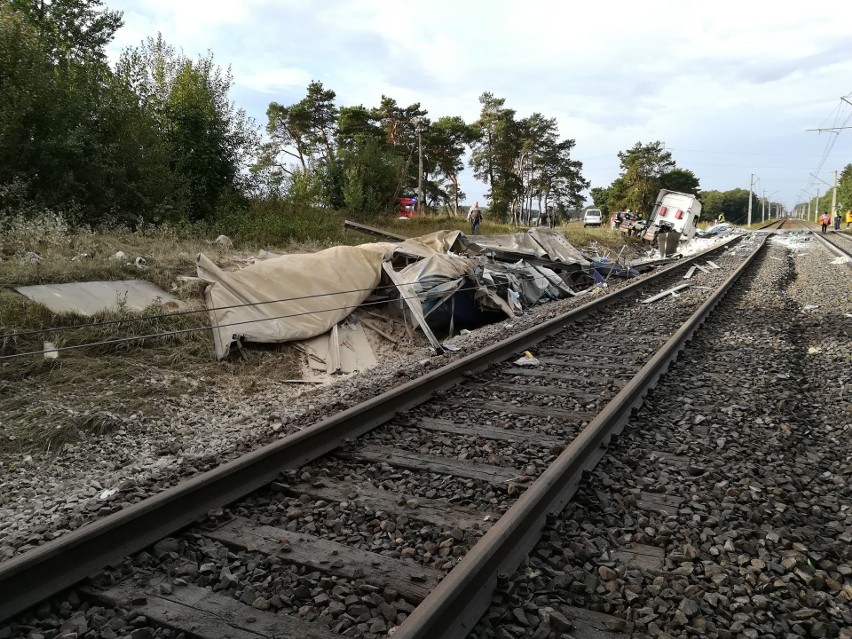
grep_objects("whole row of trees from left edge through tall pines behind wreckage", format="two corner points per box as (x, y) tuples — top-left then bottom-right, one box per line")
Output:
(0, 0), (588, 226)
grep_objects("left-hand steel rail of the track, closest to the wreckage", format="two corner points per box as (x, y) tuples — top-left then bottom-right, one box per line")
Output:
(0, 236), (741, 621)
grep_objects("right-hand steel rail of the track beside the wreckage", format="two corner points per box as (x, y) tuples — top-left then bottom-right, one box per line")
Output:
(394, 236), (769, 639)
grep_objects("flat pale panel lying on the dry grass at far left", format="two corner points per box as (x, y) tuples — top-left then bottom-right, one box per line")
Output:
(15, 280), (184, 316)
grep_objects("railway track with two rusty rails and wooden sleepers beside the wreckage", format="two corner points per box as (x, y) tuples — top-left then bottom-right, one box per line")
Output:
(0, 232), (765, 637)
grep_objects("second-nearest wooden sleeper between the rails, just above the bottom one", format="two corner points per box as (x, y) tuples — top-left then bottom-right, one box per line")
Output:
(202, 517), (444, 603)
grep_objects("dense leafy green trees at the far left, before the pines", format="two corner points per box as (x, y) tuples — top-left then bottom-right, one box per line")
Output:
(0, 0), (258, 225)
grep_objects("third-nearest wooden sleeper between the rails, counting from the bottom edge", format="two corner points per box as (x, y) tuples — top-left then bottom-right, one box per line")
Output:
(272, 478), (500, 531)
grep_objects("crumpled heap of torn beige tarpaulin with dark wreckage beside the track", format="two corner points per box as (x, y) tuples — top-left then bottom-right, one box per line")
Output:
(198, 229), (593, 359)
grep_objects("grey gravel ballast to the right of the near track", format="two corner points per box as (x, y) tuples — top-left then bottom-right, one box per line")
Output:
(471, 236), (852, 639)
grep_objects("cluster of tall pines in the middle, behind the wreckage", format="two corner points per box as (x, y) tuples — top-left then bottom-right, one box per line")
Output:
(254, 87), (588, 222)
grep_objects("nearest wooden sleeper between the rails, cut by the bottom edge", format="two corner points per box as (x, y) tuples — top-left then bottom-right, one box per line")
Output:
(86, 581), (341, 639)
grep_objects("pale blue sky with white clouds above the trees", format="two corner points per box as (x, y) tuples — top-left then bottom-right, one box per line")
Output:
(104, 0), (852, 214)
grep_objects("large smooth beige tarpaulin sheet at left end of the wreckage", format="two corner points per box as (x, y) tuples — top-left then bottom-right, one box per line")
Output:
(198, 244), (387, 359)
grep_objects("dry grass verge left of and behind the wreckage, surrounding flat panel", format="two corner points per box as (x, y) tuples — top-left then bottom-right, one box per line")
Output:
(0, 210), (635, 454)
